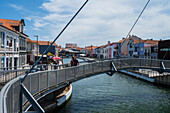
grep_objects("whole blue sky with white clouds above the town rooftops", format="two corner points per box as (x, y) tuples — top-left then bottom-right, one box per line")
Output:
(0, 0), (170, 47)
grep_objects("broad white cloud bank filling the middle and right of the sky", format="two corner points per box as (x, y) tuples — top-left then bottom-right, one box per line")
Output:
(34, 0), (170, 46)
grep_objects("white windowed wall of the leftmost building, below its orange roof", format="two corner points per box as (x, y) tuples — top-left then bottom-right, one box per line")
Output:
(0, 26), (19, 69)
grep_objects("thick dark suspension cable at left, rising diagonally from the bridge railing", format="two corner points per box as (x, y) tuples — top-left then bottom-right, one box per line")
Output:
(21, 0), (89, 83)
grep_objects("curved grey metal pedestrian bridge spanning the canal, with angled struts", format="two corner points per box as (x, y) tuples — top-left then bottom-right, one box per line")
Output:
(0, 58), (170, 113)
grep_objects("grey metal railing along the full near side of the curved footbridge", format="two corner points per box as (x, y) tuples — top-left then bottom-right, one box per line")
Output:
(0, 59), (170, 113)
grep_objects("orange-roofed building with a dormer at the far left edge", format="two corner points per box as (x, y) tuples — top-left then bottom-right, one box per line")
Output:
(0, 19), (28, 69)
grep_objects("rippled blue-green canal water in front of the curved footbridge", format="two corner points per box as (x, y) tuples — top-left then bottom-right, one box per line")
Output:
(55, 58), (170, 113)
